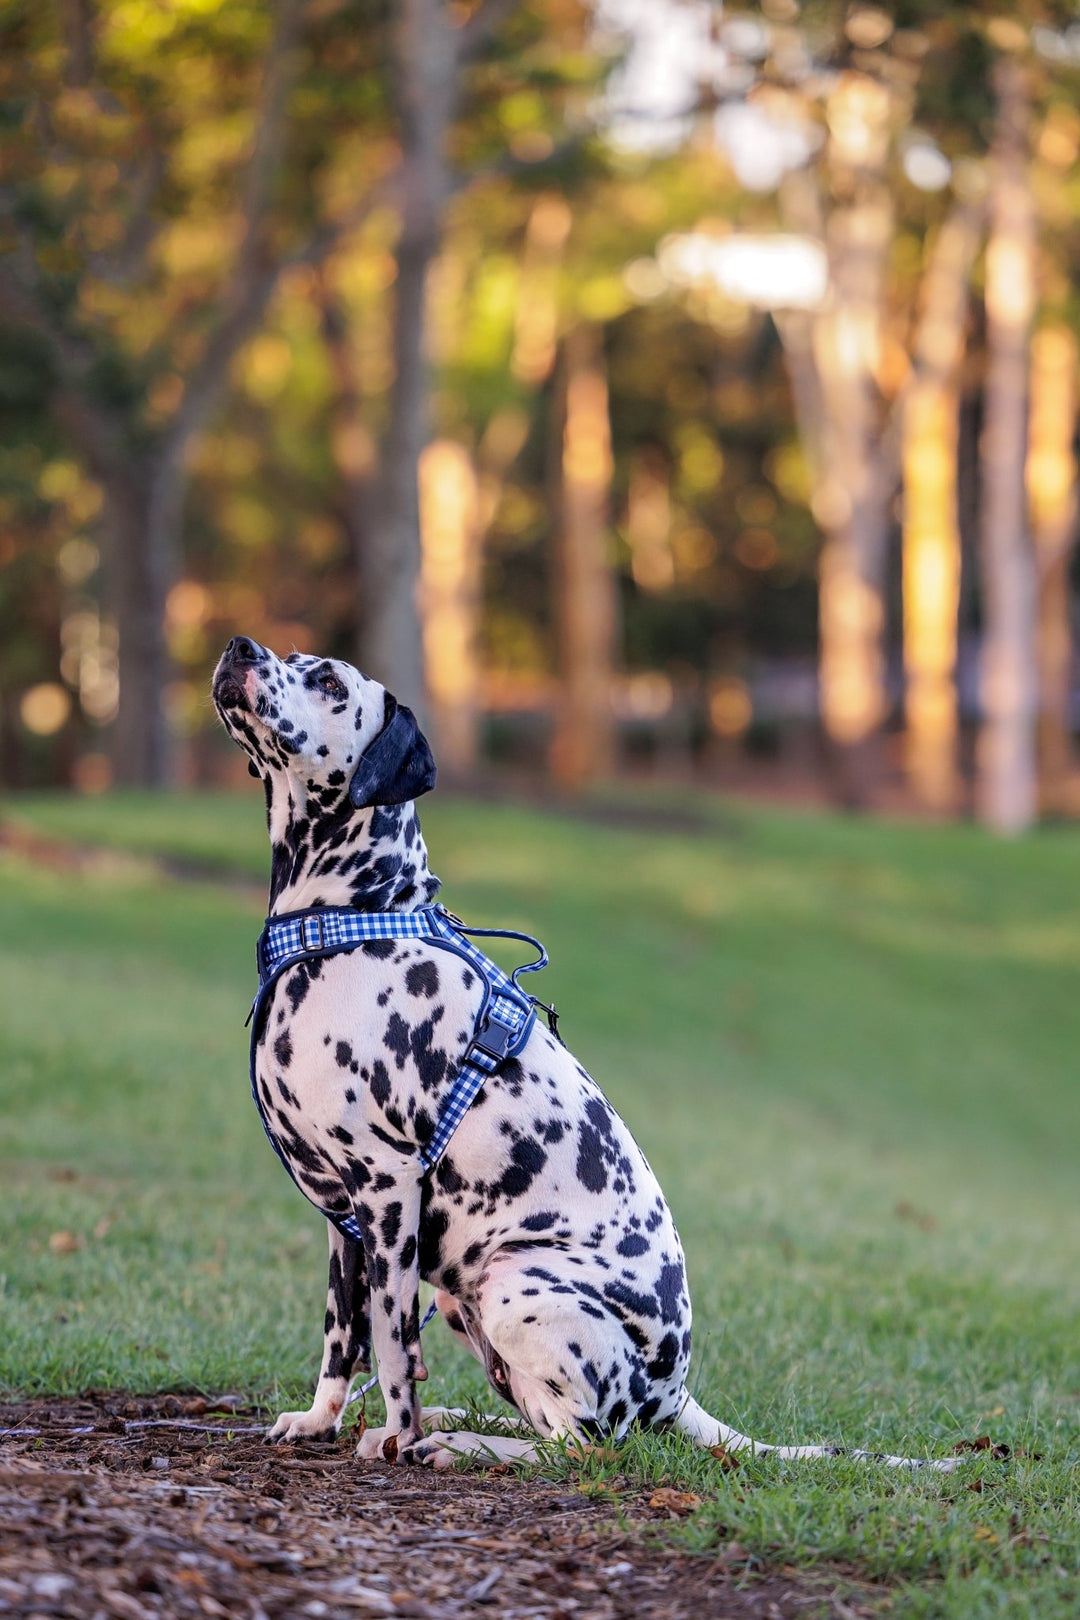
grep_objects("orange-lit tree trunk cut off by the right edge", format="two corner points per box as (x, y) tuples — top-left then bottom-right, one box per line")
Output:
(1027, 326), (1077, 815)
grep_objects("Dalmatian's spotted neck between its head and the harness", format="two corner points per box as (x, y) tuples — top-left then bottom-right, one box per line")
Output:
(264, 771), (439, 915)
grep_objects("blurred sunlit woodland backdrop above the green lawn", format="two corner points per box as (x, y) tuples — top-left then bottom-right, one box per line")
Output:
(0, 0), (1080, 833)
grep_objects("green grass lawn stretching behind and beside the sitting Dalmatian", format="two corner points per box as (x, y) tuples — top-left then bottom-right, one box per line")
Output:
(0, 786), (1080, 1620)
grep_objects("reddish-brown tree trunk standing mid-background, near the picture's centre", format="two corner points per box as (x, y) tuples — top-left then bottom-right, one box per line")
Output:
(551, 324), (619, 789)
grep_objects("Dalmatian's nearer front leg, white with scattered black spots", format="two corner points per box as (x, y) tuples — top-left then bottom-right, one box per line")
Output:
(356, 1166), (427, 1463)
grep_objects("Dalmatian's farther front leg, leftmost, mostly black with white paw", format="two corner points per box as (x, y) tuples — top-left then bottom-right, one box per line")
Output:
(269, 1221), (371, 1440)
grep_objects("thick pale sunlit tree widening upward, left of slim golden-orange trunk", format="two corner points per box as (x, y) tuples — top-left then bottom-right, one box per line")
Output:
(709, 5), (923, 805)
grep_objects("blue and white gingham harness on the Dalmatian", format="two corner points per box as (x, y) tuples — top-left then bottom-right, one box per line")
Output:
(248, 906), (559, 1243)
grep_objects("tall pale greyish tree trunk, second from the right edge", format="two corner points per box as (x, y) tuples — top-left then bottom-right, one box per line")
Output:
(976, 58), (1038, 834)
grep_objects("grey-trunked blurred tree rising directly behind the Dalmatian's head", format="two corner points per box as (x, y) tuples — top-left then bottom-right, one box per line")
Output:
(310, 0), (594, 722)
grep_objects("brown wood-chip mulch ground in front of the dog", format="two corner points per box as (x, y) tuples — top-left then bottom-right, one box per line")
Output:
(0, 1395), (882, 1620)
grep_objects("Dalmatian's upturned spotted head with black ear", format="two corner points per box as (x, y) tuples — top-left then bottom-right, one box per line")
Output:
(214, 635), (436, 808)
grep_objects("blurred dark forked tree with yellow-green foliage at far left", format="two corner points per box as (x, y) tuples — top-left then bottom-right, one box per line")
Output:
(0, 0), (399, 782)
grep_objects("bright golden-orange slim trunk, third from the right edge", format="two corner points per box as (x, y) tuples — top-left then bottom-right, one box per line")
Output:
(904, 204), (981, 813)
